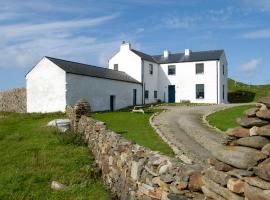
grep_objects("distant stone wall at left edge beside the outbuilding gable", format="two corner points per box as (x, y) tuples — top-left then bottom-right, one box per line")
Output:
(0, 88), (26, 113)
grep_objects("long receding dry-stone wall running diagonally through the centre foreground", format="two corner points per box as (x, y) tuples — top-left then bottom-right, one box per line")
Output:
(67, 102), (204, 200)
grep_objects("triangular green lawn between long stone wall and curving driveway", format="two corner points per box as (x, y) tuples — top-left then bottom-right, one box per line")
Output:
(93, 109), (174, 156)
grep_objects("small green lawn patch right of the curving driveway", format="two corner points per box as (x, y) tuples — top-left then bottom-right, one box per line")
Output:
(207, 105), (254, 131)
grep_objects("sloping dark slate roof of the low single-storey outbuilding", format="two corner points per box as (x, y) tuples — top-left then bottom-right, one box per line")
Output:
(46, 56), (140, 84)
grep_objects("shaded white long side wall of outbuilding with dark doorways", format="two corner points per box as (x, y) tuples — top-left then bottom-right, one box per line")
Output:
(67, 73), (142, 111)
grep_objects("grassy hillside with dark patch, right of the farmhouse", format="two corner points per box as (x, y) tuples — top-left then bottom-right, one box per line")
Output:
(228, 79), (270, 103)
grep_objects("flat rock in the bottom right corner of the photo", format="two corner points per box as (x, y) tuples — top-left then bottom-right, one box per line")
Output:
(245, 183), (270, 200)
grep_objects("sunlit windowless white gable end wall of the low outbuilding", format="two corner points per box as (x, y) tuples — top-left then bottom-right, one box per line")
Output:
(26, 58), (66, 113)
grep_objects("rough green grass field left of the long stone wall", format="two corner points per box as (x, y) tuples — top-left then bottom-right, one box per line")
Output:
(0, 113), (110, 200)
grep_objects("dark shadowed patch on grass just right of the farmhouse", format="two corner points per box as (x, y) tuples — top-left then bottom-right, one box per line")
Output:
(228, 90), (256, 103)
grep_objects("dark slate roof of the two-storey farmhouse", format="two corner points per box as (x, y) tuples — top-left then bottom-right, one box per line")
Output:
(131, 49), (224, 64)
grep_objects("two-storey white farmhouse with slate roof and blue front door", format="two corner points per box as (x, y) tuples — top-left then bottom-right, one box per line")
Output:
(109, 42), (228, 104)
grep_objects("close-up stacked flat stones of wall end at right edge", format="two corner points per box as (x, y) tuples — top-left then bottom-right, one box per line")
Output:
(202, 97), (270, 200)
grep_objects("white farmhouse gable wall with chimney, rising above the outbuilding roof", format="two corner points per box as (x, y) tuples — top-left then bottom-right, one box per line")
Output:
(109, 43), (142, 82)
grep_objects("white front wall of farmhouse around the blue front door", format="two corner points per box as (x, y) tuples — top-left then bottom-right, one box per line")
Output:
(159, 61), (218, 103)
